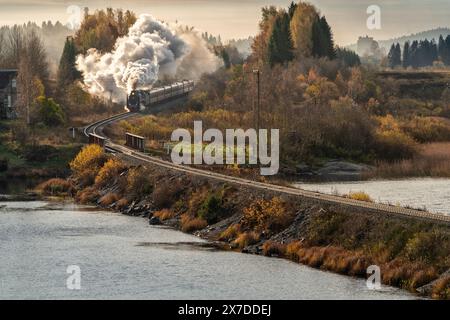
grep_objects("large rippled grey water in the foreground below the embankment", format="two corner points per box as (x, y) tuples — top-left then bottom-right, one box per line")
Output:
(0, 201), (415, 299)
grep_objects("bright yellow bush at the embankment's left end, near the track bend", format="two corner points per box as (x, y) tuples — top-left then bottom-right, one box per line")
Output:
(70, 144), (108, 185)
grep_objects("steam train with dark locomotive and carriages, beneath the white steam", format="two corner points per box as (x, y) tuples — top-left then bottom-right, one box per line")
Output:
(127, 80), (194, 112)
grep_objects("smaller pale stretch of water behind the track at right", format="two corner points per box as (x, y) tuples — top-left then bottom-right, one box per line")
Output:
(295, 178), (450, 215)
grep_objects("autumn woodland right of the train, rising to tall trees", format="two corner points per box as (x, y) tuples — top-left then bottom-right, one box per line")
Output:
(118, 2), (450, 176)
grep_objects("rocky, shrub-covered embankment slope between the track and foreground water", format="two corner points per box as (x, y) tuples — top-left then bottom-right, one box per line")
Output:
(37, 146), (450, 298)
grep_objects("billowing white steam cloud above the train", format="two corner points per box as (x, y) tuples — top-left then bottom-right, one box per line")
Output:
(76, 14), (222, 102)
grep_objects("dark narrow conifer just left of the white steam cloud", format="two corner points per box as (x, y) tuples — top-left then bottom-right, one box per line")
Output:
(57, 37), (81, 89)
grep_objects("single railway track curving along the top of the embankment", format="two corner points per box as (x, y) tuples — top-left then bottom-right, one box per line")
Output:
(84, 112), (450, 225)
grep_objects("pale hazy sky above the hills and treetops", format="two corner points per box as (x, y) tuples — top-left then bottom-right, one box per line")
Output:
(0, 0), (450, 45)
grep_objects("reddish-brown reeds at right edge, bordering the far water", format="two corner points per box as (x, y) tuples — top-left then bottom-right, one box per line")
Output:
(364, 142), (450, 178)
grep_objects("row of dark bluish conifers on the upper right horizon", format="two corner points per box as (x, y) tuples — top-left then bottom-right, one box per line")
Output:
(387, 35), (450, 68)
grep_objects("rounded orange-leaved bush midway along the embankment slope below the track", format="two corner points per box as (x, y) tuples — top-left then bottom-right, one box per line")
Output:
(243, 197), (293, 232)
